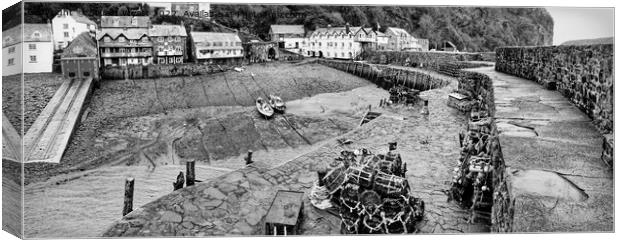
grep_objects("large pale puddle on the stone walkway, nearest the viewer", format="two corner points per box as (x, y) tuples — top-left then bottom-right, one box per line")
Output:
(506, 169), (588, 202)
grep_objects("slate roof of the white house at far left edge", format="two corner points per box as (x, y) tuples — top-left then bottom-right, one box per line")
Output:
(2, 23), (52, 47)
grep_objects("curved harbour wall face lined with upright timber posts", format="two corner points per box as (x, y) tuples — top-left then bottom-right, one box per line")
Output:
(317, 59), (449, 91)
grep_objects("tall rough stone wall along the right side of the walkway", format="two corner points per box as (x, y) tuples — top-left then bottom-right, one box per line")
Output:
(495, 44), (614, 133)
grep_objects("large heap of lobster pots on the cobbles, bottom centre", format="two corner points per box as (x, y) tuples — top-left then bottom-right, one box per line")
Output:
(324, 143), (424, 234)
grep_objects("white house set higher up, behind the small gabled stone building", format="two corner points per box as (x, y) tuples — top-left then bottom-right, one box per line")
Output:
(52, 9), (97, 50)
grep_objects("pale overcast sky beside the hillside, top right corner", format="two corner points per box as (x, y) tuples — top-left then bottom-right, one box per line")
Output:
(547, 7), (614, 45)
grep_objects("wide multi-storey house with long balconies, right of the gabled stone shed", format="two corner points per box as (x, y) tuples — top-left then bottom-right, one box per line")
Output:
(97, 16), (153, 66)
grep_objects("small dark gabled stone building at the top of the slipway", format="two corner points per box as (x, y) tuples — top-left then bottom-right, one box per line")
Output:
(60, 32), (99, 79)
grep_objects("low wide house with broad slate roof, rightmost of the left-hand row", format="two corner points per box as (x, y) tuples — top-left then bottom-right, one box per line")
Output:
(190, 32), (244, 64)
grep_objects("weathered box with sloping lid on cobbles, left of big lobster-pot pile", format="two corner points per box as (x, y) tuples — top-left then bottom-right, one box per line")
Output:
(265, 190), (304, 236)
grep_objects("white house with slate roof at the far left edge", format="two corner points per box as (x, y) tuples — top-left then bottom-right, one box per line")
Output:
(2, 24), (54, 76)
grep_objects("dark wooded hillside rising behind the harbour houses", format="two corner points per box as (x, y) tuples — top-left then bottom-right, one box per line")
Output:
(211, 4), (553, 51)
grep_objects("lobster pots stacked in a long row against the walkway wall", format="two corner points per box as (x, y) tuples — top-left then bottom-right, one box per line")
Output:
(451, 109), (493, 216)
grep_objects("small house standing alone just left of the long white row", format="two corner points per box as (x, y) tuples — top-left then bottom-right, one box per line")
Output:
(269, 25), (307, 53)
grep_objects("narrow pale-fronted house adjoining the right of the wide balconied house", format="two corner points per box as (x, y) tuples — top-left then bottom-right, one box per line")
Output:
(149, 25), (187, 64)
